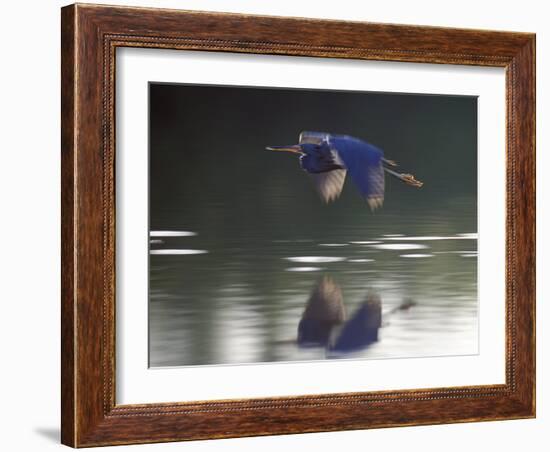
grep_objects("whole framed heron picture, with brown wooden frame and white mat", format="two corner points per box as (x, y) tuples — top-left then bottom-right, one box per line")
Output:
(61, 4), (535, 447)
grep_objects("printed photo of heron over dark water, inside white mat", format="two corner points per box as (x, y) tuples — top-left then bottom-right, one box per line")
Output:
(148, 82), (479, 367)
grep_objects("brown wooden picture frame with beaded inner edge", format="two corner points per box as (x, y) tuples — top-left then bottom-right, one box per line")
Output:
(61, 4), (535, 447)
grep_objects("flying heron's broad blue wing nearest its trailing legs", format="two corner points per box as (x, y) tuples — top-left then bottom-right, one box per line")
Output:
(331, 139), (384, 210)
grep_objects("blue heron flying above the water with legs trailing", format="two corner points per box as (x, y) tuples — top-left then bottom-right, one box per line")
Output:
(266, 132), (423, 210)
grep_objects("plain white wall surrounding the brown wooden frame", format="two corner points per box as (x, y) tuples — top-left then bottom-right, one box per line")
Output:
(0, 0), (550, 452)
